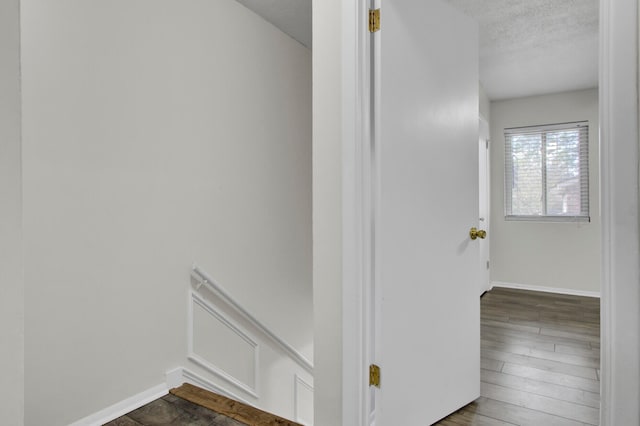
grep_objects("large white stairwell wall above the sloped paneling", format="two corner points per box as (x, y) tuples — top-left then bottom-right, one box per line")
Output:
(21, 0), (313, 425)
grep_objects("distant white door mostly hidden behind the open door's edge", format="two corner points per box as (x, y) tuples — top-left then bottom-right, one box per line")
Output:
(478, 117), (491, 295)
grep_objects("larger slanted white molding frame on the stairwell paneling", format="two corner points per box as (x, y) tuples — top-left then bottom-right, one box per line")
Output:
(187, 291), (260, 399)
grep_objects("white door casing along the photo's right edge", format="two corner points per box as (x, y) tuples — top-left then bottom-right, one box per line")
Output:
(599, 0), (640, 426)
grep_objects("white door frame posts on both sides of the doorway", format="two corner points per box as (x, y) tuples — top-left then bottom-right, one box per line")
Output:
(338, 0), (640, 426)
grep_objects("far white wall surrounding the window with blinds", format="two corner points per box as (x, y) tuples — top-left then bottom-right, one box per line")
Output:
(491, 89), (600, 292)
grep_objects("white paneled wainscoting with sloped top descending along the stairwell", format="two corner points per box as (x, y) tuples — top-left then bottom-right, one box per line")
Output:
(187, 269), (313, 425)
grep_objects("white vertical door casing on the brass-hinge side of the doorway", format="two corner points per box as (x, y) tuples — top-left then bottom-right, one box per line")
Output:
(342, 0), (373, 426)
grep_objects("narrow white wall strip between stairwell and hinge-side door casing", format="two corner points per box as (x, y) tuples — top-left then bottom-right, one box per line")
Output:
(313, 0), (343, 426)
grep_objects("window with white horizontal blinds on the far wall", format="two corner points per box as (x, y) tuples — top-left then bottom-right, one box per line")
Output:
(505, 122), (589, 221)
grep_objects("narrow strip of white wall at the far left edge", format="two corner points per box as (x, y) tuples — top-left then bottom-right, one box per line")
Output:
(0, 0), (24, 425)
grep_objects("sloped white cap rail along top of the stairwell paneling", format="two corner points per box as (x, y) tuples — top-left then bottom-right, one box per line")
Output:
(191, 264), (313, 374)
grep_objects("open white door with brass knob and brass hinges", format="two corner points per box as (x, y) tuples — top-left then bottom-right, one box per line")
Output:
(374, 0), (480, 426)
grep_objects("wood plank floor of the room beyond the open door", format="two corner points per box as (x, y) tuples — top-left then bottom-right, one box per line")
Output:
(437, 288), (600, 426)
